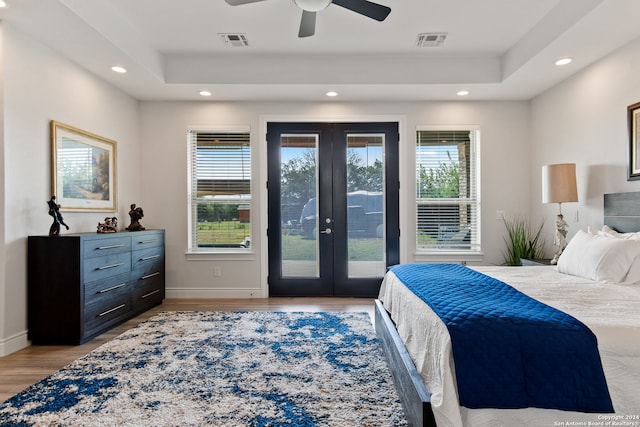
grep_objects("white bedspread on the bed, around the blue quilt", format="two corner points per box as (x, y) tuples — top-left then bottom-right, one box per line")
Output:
(379, 266), (640, 427)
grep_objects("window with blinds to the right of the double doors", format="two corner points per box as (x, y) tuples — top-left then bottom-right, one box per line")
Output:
(416, 129), (480, 252)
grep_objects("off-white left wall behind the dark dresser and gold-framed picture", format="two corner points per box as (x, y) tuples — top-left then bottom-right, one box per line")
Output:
(0, 23), (140, 355)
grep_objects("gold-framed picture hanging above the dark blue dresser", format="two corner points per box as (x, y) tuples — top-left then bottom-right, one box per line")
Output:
(51, 120), (118, 212)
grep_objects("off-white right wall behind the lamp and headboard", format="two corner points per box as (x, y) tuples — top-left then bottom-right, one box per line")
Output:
(530, 39), (640, 254)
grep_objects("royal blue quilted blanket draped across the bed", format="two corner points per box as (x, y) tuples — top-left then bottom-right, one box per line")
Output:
(390, 264), (613, 413)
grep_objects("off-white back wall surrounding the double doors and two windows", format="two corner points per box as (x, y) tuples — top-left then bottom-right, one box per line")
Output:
(140, 102), (530, 297)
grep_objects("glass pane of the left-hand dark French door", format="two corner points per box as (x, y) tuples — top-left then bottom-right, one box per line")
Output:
(280, 134), (320, 278)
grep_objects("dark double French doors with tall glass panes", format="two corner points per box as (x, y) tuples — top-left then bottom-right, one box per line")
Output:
(267, 122), (400, 297)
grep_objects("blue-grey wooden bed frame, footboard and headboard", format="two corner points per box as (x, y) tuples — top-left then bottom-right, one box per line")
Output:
(374, 191), (640, 427)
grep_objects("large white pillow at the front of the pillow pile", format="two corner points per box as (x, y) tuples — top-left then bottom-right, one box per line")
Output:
(558, 230), (640, 283)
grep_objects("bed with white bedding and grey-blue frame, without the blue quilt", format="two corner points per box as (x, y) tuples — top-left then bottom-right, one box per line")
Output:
(375, 192), (640, 427)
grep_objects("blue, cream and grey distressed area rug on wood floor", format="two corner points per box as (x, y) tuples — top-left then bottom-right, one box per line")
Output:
(0, 312), (406, 427)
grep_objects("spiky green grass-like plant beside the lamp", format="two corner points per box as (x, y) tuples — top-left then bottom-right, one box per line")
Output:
(502, 217), (544, 265)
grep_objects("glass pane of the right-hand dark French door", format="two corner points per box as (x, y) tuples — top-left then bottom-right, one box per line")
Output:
(346, 134), (386, 278)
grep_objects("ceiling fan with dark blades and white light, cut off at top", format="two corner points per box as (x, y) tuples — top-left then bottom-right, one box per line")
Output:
(225, 0), (391, 37)
